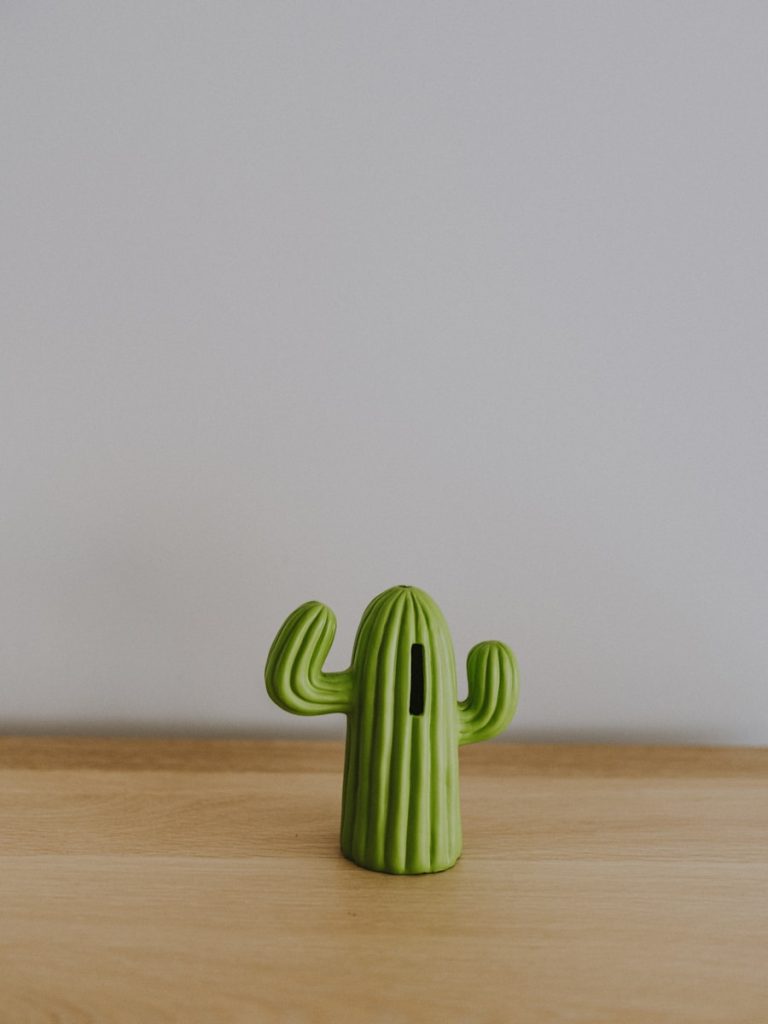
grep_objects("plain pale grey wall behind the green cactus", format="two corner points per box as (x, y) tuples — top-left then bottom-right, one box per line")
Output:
(0, 0), (768, 743)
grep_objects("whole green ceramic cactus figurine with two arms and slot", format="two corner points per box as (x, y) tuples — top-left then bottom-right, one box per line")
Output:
(265, 587), (517, 874)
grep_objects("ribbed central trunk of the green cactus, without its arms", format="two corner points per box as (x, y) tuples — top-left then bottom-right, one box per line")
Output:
(341, 588), (461, 874)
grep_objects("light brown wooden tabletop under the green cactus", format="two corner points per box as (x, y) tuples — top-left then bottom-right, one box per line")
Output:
(0, 738), (768, 1024)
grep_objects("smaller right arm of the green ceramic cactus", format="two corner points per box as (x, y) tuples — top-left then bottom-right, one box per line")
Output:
(459, 640), (518, 744)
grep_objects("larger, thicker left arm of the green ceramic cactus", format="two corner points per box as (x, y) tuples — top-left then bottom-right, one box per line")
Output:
(264, 601), (352, 715)
